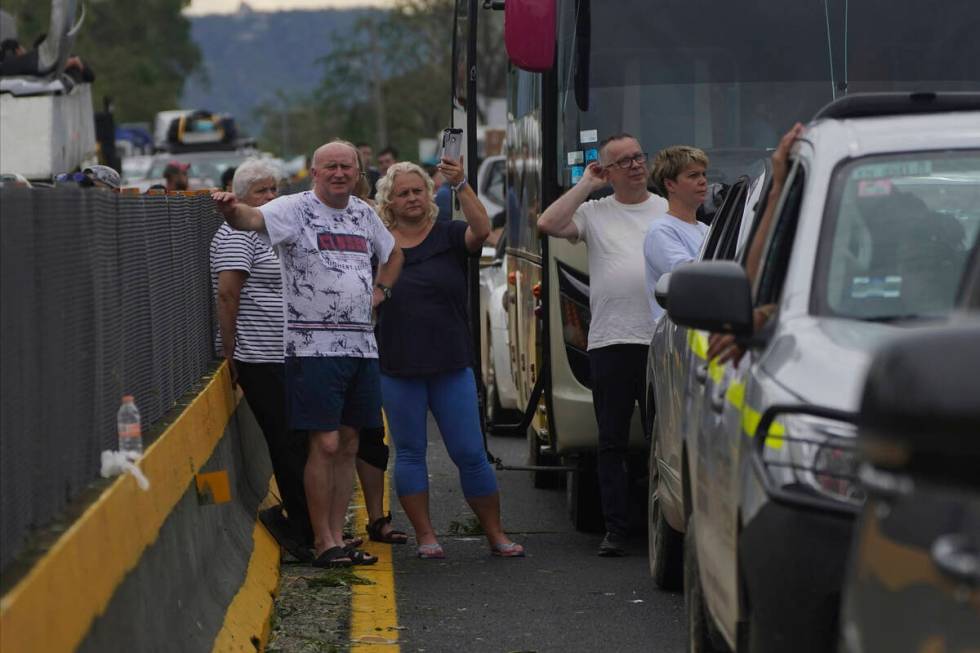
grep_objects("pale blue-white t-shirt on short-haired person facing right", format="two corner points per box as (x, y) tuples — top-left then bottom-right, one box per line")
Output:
(643, 211), (708, 323)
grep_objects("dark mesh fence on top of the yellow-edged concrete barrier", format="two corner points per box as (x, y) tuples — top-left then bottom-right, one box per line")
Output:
(0, 186), (221, 569)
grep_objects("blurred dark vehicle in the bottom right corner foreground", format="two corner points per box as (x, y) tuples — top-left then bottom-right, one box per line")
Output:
(839, 247), (980, 653)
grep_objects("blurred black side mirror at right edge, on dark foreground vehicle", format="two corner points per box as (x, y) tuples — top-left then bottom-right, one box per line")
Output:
(858, 322), (980, 488)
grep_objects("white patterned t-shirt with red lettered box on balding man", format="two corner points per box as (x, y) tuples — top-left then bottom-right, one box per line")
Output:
(259, 191), (395, 358)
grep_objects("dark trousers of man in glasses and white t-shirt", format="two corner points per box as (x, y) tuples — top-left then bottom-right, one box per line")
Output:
(589, 345), (649, 535)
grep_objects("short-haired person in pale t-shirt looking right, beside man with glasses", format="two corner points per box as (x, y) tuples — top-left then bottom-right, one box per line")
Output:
(643, 145), (708, 322)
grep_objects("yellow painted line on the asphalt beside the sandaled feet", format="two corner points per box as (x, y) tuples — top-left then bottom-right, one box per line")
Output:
(350, 424), (406, 653)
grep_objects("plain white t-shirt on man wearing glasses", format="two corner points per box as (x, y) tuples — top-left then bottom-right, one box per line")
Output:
(572, 195), (667, 351)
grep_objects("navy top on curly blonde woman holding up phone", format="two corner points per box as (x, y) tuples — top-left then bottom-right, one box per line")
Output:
(376, 220), (476, 376)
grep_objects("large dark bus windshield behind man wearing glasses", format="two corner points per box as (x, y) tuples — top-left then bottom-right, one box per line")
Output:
(557, 0), (980, 187)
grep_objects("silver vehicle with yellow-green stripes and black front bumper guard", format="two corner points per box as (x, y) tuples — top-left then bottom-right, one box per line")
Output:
(667, 94), (980, 651)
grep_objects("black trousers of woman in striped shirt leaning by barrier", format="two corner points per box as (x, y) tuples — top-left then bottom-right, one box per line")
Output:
(235, 361), (313, 542)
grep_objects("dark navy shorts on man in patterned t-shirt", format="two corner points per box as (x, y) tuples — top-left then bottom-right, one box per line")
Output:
(286, 356), (381, 431)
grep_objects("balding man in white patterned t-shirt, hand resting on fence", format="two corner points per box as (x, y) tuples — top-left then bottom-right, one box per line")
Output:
(212, 141), (403, 567)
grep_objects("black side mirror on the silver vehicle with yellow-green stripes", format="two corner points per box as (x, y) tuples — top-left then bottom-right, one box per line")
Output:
(667, 261), (753, 336)
